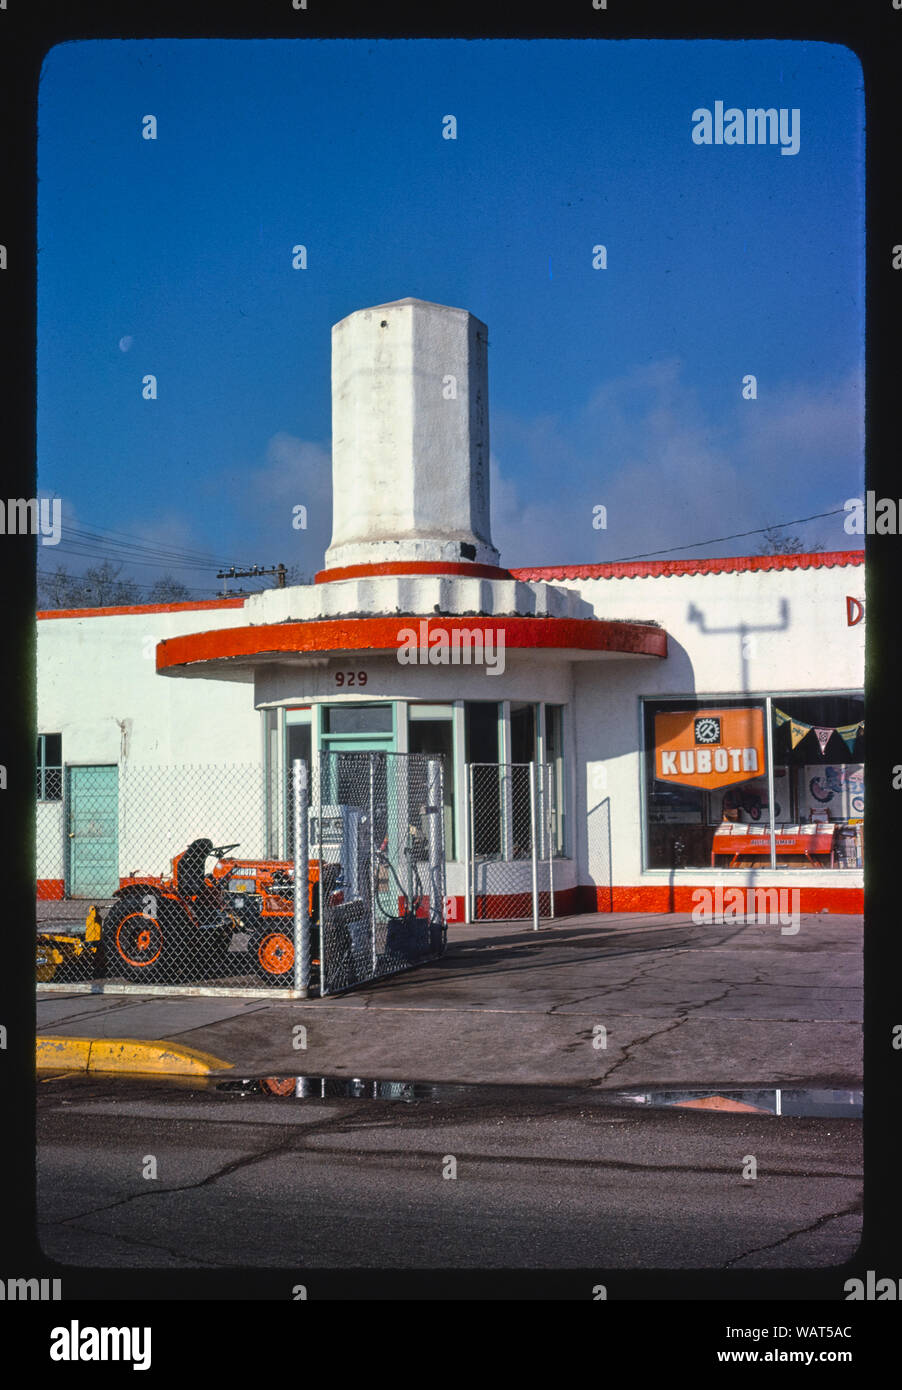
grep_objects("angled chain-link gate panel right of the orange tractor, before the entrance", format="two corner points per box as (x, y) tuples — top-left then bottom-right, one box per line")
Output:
(316, 751), (446, 995)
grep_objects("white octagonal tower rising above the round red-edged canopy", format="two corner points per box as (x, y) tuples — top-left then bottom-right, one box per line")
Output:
(322, 299), (499, 578)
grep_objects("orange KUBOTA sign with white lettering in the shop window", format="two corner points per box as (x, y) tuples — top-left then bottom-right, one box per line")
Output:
(655, 709), (764, 791)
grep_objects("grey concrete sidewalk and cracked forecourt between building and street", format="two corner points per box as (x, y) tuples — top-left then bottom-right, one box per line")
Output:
(38, 913), (863, 1090)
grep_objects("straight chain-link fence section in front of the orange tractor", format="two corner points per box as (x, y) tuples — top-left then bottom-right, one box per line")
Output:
(36, 763), (302, 991)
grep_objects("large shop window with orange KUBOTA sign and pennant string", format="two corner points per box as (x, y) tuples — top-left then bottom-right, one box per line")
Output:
(645, 695), (864, 869)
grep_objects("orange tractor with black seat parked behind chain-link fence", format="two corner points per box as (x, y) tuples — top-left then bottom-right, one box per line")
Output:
(97, 840), (334, 984)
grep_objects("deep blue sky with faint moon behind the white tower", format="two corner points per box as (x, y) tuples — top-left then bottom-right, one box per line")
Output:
(38, 40), (864, 596)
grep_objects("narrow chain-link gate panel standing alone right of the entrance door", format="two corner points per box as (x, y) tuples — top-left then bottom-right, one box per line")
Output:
(467, 763), (555, 927)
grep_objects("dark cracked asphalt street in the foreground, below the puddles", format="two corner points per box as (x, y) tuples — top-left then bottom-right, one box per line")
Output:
(38, 1074), (862, 1273)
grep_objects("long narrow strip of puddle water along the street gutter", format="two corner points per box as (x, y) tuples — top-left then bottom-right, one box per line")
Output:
(215, 1076), (863, 1119)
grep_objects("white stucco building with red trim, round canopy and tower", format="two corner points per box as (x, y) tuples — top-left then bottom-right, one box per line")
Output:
(38, 299), (864, 923)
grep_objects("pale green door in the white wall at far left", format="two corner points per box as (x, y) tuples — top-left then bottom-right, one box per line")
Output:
(65, 766), (120, 898)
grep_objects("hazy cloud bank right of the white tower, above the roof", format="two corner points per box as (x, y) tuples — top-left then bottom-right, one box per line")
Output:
(492, 359), (863, 567)
